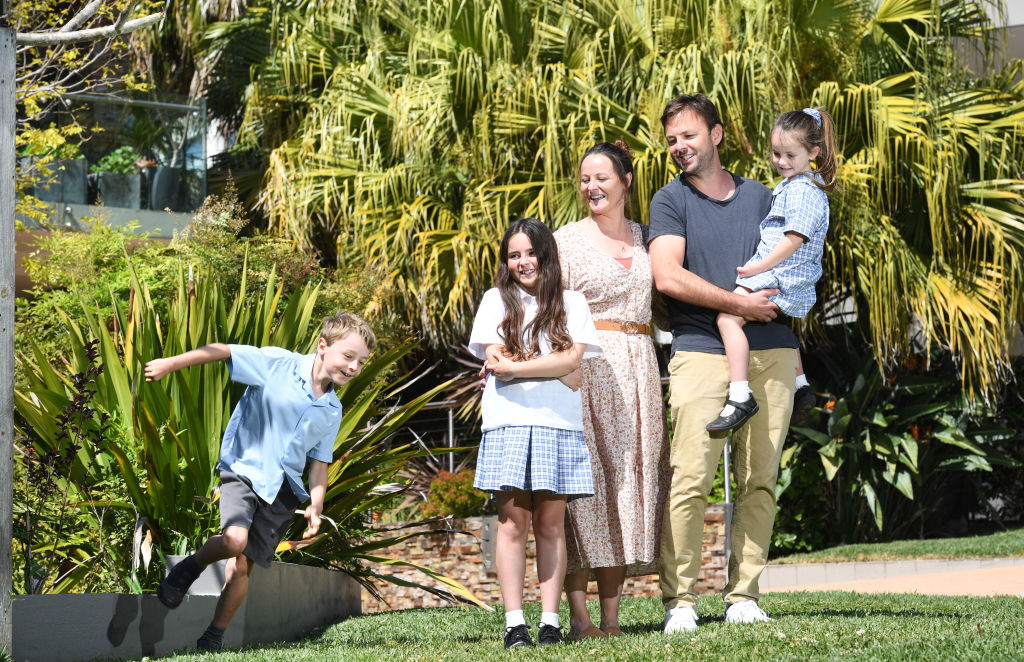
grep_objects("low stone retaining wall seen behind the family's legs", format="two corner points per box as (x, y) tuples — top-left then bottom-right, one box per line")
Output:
(362, 503), (726, 614)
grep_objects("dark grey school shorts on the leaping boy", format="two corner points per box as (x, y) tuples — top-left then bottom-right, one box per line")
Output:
(220, 471), (299, 568)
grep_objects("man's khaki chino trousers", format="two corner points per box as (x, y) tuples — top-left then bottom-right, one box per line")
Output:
(660, 347), (797, 609)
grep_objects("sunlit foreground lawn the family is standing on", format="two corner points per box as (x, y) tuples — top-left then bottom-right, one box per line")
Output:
(157, 592), (1024, 662)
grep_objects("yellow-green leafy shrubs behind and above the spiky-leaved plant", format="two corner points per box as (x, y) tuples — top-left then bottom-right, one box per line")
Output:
(15, 191), (409, 384)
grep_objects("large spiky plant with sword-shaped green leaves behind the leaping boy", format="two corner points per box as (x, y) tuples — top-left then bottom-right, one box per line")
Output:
(14, 259), (480, 604)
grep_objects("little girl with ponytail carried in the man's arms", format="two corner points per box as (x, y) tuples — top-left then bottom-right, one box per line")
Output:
(708, 108), (836, 432)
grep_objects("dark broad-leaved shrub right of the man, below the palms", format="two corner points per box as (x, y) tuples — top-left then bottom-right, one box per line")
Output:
(772, 329), (1020, 554)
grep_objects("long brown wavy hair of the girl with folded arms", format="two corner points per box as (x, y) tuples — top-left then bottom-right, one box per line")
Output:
(495, 218), (572, 361)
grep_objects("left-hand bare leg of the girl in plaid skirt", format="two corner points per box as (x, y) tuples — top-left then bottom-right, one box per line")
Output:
(495, 490), (531, 612)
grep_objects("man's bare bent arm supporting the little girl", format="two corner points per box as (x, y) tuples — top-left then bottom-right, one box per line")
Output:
(649, 235), (778, 322)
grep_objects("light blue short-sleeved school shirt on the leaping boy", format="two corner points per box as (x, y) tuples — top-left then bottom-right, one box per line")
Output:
(217, 344), (341, 503)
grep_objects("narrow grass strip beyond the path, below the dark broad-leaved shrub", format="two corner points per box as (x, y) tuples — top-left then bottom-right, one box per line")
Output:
(771, 529), (1024, 564)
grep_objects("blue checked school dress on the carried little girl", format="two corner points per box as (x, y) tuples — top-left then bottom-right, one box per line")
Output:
(736, 175), (828, 318)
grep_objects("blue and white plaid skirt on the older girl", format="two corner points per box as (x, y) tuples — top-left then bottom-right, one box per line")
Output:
(473, 425), (594, 501)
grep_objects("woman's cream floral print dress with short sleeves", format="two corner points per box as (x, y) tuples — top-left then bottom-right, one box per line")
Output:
(555, 221), (670, 576)
